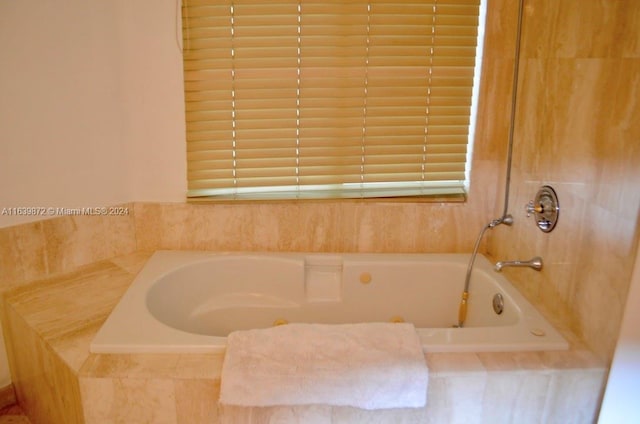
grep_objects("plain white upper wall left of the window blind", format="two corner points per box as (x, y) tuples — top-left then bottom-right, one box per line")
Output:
(0, 0), (186, 227)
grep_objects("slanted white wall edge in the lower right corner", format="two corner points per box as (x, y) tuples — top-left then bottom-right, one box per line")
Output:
(598, 243), (640, 424)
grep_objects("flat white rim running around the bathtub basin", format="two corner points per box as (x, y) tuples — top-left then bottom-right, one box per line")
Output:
(89, 250), (569, 354)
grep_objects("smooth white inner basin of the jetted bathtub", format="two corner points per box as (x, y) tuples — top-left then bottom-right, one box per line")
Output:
(146, 255), (521, 337)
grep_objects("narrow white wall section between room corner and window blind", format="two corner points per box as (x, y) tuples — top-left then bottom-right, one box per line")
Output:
(118, 0), (187, 202)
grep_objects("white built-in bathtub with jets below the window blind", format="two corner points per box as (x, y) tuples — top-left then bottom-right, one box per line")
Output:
(90, 251), (568, 353)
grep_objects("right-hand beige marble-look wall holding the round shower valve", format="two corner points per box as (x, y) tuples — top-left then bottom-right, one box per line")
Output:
(488, 0), (640, 360)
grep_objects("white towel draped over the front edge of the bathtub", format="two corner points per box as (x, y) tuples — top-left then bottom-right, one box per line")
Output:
(220, 323), (429, 409)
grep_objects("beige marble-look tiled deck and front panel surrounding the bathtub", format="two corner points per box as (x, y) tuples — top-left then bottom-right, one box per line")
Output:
(3, 252), (606, 423)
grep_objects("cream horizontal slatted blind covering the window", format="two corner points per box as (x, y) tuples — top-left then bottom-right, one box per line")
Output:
(183, 0), (479, 198)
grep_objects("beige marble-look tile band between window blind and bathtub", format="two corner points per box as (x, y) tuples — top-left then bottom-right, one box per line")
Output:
(131, 198), (484, 252)
